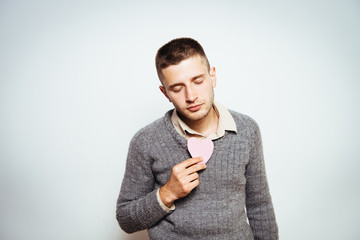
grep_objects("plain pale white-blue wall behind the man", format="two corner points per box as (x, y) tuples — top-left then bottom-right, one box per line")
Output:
(0, 0), (360, 240)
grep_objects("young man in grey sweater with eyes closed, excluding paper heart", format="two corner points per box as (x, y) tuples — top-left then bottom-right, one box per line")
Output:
(116, 38), (278, 240)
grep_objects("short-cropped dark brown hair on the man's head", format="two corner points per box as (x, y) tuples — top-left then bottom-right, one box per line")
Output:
(155, 38), (210, 81)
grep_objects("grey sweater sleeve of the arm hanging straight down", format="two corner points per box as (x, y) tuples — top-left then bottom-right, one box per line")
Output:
(246, 122), (279, 240)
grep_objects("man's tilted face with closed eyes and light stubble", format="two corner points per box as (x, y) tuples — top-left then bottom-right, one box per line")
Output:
(160, 55), (216, 123)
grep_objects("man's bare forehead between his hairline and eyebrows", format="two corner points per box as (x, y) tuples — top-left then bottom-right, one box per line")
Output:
(162, 55), (208, 86)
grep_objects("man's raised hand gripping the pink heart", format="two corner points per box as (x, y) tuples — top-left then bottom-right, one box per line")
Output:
(159, 157), (206, 207)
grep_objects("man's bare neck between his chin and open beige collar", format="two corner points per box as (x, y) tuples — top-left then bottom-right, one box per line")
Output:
(183, 107), (219, 137)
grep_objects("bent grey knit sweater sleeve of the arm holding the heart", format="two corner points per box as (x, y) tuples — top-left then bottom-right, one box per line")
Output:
(116, 139), (168, 233)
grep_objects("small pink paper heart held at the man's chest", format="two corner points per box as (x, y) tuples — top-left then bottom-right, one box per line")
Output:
(187, 137), (214, 164)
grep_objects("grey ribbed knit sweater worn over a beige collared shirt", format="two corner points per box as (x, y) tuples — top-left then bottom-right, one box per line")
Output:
(116, 110), (278, 240)
